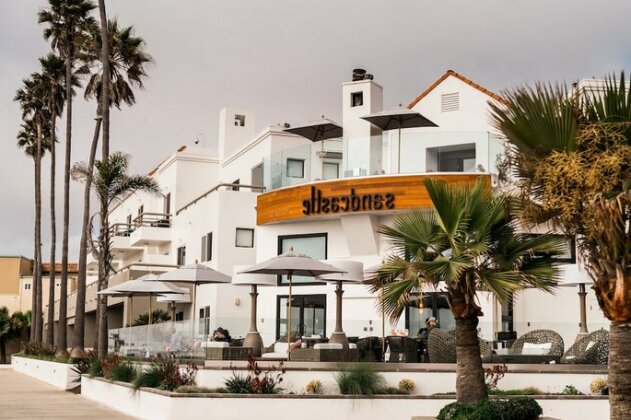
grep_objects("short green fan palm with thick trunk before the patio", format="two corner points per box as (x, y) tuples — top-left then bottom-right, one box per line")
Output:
(372, 178), (564, 404)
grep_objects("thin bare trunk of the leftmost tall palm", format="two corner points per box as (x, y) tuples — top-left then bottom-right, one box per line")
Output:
(33, 123), (44, 342)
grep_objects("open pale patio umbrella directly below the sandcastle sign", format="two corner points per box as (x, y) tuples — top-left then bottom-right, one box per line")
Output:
(239, 247), (344, 353)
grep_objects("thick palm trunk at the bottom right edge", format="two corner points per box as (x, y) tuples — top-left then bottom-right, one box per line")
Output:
(608, 321), (631, 420)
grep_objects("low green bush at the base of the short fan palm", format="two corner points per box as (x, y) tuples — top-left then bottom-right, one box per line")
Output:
(436, 398), (543, 420)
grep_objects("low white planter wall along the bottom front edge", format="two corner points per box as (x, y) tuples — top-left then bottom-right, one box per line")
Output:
(81, 375), (609, 420)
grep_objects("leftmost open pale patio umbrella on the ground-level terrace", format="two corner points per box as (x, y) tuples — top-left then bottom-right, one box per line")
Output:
(97, 274), (187, 352)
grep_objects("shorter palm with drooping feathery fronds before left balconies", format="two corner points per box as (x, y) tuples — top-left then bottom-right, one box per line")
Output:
(72, 152), (160, 357)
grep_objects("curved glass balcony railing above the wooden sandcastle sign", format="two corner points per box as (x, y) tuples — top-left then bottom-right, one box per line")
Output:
(263, 130), (504, 191)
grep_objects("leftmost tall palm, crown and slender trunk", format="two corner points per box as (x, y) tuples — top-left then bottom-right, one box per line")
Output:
(13, 73), (50, 341)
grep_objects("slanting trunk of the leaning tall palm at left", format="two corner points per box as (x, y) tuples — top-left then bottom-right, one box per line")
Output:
(70, 110), (101, 357)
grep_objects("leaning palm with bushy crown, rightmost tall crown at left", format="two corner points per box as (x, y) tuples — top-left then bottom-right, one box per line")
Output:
(72, 19), (152, 357)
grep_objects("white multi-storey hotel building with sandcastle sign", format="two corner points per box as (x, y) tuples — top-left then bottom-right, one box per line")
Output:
(61, 71), (607, 348)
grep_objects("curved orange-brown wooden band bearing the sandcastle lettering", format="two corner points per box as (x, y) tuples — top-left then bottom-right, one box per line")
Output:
(256, 174), (491, 225)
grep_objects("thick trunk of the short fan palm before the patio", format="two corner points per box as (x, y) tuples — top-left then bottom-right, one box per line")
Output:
(456, 316), (488, 404)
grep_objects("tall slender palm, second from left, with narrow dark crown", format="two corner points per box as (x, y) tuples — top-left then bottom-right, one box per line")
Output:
(39, 53), (74, 346)
